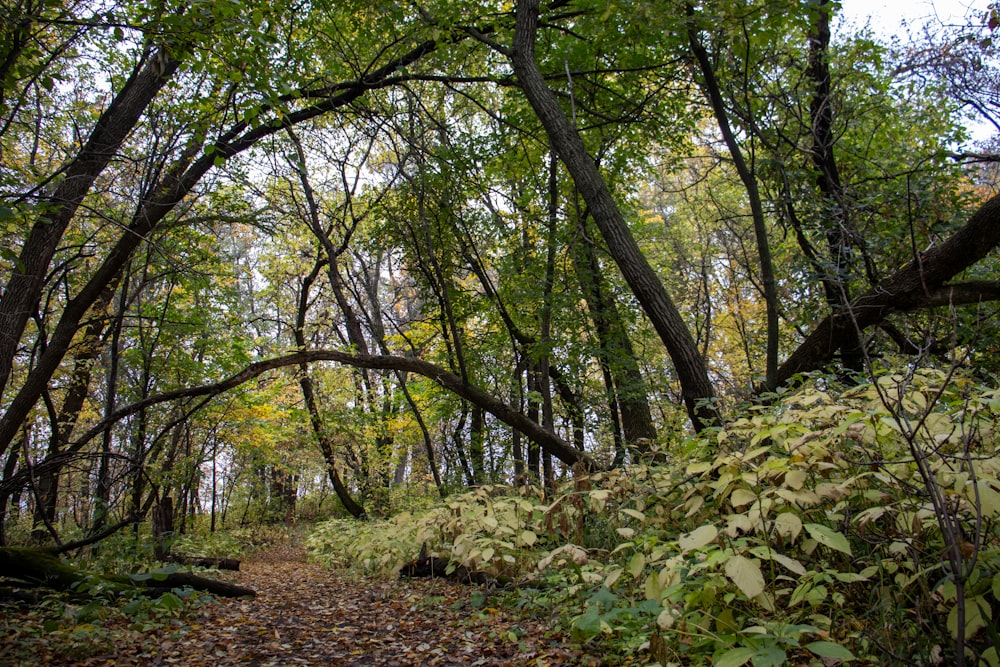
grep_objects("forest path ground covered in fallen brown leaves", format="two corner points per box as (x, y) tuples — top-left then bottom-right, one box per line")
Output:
(0, 545), (600, 667)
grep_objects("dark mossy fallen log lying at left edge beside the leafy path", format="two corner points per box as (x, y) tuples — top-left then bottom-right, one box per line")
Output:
(0, 547), (255, 597)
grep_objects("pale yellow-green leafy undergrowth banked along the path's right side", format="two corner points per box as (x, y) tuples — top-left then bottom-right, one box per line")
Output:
(306, 370), (1000, 667)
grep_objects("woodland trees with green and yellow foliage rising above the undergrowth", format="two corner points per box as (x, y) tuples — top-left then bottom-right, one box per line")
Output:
(0, 0), (1000, 544)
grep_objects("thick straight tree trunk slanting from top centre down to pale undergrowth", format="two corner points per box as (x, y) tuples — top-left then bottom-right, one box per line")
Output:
(510, 0), (721, 431)
